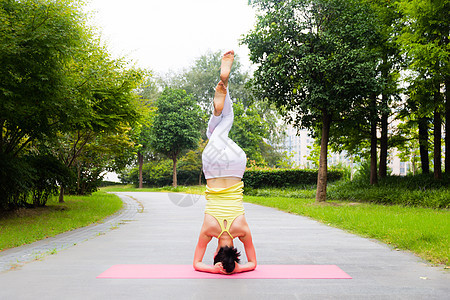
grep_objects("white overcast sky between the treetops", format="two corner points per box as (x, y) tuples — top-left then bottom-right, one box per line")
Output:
(86, 0), (255, 73)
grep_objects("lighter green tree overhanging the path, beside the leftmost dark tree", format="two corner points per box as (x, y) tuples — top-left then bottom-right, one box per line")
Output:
(53, 40), (144, 202)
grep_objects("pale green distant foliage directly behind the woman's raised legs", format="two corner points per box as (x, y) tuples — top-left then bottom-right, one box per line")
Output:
(162, 51), (283, 166)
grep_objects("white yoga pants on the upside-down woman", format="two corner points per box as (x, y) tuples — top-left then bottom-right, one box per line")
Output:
(202, 88), (247, 179)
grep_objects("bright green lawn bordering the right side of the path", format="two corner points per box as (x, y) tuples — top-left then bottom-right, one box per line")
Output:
(244, 196), (450, 266)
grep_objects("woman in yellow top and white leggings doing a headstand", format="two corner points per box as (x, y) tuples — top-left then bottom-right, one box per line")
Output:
(194, 51), (256, 274)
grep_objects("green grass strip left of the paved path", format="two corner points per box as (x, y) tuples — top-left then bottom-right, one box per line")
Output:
(0, 191), (123, 251)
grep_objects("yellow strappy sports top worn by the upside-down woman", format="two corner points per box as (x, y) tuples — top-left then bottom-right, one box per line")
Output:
(205, 181), (245, 239)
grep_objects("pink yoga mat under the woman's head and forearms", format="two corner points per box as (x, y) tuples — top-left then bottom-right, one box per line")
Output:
(97, 265), (352, 279)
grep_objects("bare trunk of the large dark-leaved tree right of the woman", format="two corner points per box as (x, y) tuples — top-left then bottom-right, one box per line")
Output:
(316, 111), (331, 202)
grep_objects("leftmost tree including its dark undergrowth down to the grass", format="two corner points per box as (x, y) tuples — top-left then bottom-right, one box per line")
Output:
(0, 0), (90, 206)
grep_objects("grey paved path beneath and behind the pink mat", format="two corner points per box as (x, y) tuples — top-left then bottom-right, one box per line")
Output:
(0, 193), (450, 299)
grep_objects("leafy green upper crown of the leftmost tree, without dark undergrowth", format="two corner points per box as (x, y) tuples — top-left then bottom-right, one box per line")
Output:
(0, 0), (85, 156)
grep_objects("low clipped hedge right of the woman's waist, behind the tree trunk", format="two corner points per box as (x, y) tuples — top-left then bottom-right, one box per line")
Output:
(242, 168), (344, 188)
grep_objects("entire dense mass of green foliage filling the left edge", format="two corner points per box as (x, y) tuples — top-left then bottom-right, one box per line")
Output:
(0, 0), (143, 206)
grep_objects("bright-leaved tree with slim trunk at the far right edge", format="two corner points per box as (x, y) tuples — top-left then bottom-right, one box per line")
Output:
(397, 0), (450, 179)
